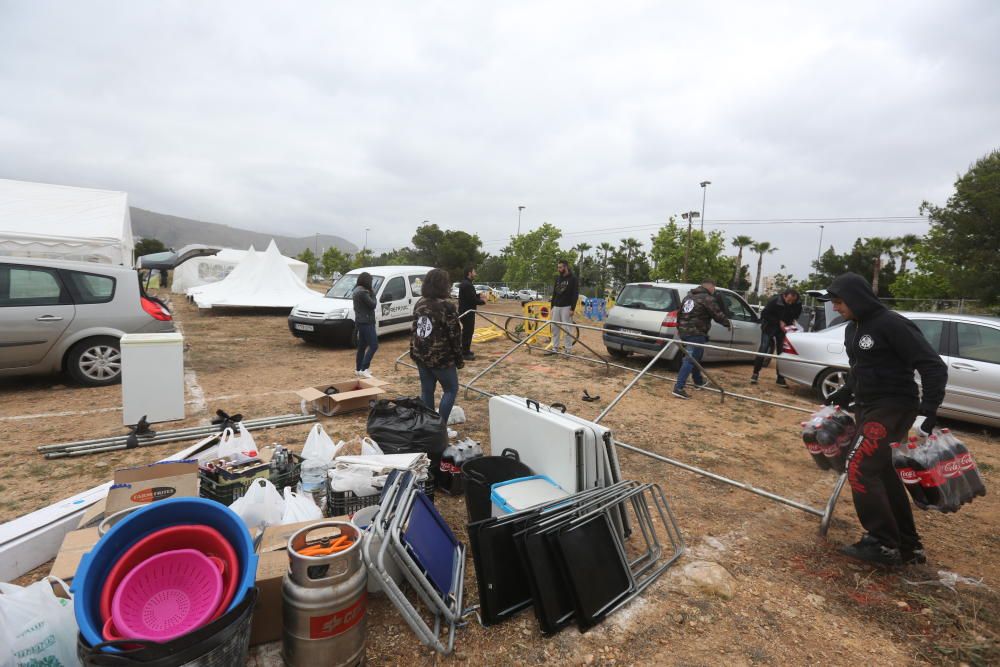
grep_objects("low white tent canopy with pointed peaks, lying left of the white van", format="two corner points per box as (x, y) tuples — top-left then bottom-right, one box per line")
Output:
(188, 241), (317, 309)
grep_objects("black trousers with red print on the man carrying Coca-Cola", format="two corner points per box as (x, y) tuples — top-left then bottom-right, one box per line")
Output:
(847, 405), (921, 549)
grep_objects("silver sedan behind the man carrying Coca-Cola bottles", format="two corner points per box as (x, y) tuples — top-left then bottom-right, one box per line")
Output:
(778, 313), (1000, 426)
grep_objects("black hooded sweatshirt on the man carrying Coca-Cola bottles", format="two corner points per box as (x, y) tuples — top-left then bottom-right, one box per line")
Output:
(827, 273), (948, 414)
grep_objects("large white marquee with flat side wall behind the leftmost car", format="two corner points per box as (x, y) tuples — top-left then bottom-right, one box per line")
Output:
(0, 179), (135, 266)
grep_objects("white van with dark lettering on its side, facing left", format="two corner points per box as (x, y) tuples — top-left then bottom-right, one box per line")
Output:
(288, 266), (432, 345)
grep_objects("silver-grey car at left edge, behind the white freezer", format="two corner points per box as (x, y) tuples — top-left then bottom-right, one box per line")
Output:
(0, 257), (174, 386)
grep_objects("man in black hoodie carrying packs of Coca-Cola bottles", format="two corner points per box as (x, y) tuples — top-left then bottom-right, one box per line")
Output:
(827, 273), (948, 565)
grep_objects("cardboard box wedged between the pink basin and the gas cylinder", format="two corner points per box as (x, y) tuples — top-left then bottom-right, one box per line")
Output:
(250, 516), (348, 646)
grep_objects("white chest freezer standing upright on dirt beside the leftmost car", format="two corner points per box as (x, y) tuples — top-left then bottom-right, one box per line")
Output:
(121, 333), (184, 425)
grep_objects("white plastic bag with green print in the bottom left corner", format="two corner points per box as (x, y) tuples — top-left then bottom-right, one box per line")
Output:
(0, 577), (80, 667)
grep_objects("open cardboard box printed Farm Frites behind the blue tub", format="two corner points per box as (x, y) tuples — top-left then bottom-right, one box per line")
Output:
(104, 461), (198, 516)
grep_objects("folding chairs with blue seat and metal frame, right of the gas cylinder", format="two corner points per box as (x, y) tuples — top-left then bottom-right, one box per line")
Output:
(362, 472), (465, 654)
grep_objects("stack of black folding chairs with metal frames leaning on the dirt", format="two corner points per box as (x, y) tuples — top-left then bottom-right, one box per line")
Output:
(469, 481), (684, 634)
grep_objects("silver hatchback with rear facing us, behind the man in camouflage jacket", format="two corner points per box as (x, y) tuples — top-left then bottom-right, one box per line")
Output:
(603, 282), (760, 370)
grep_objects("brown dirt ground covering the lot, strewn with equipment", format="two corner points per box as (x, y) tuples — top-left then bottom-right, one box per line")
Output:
(0, 299), (1000, 665)
